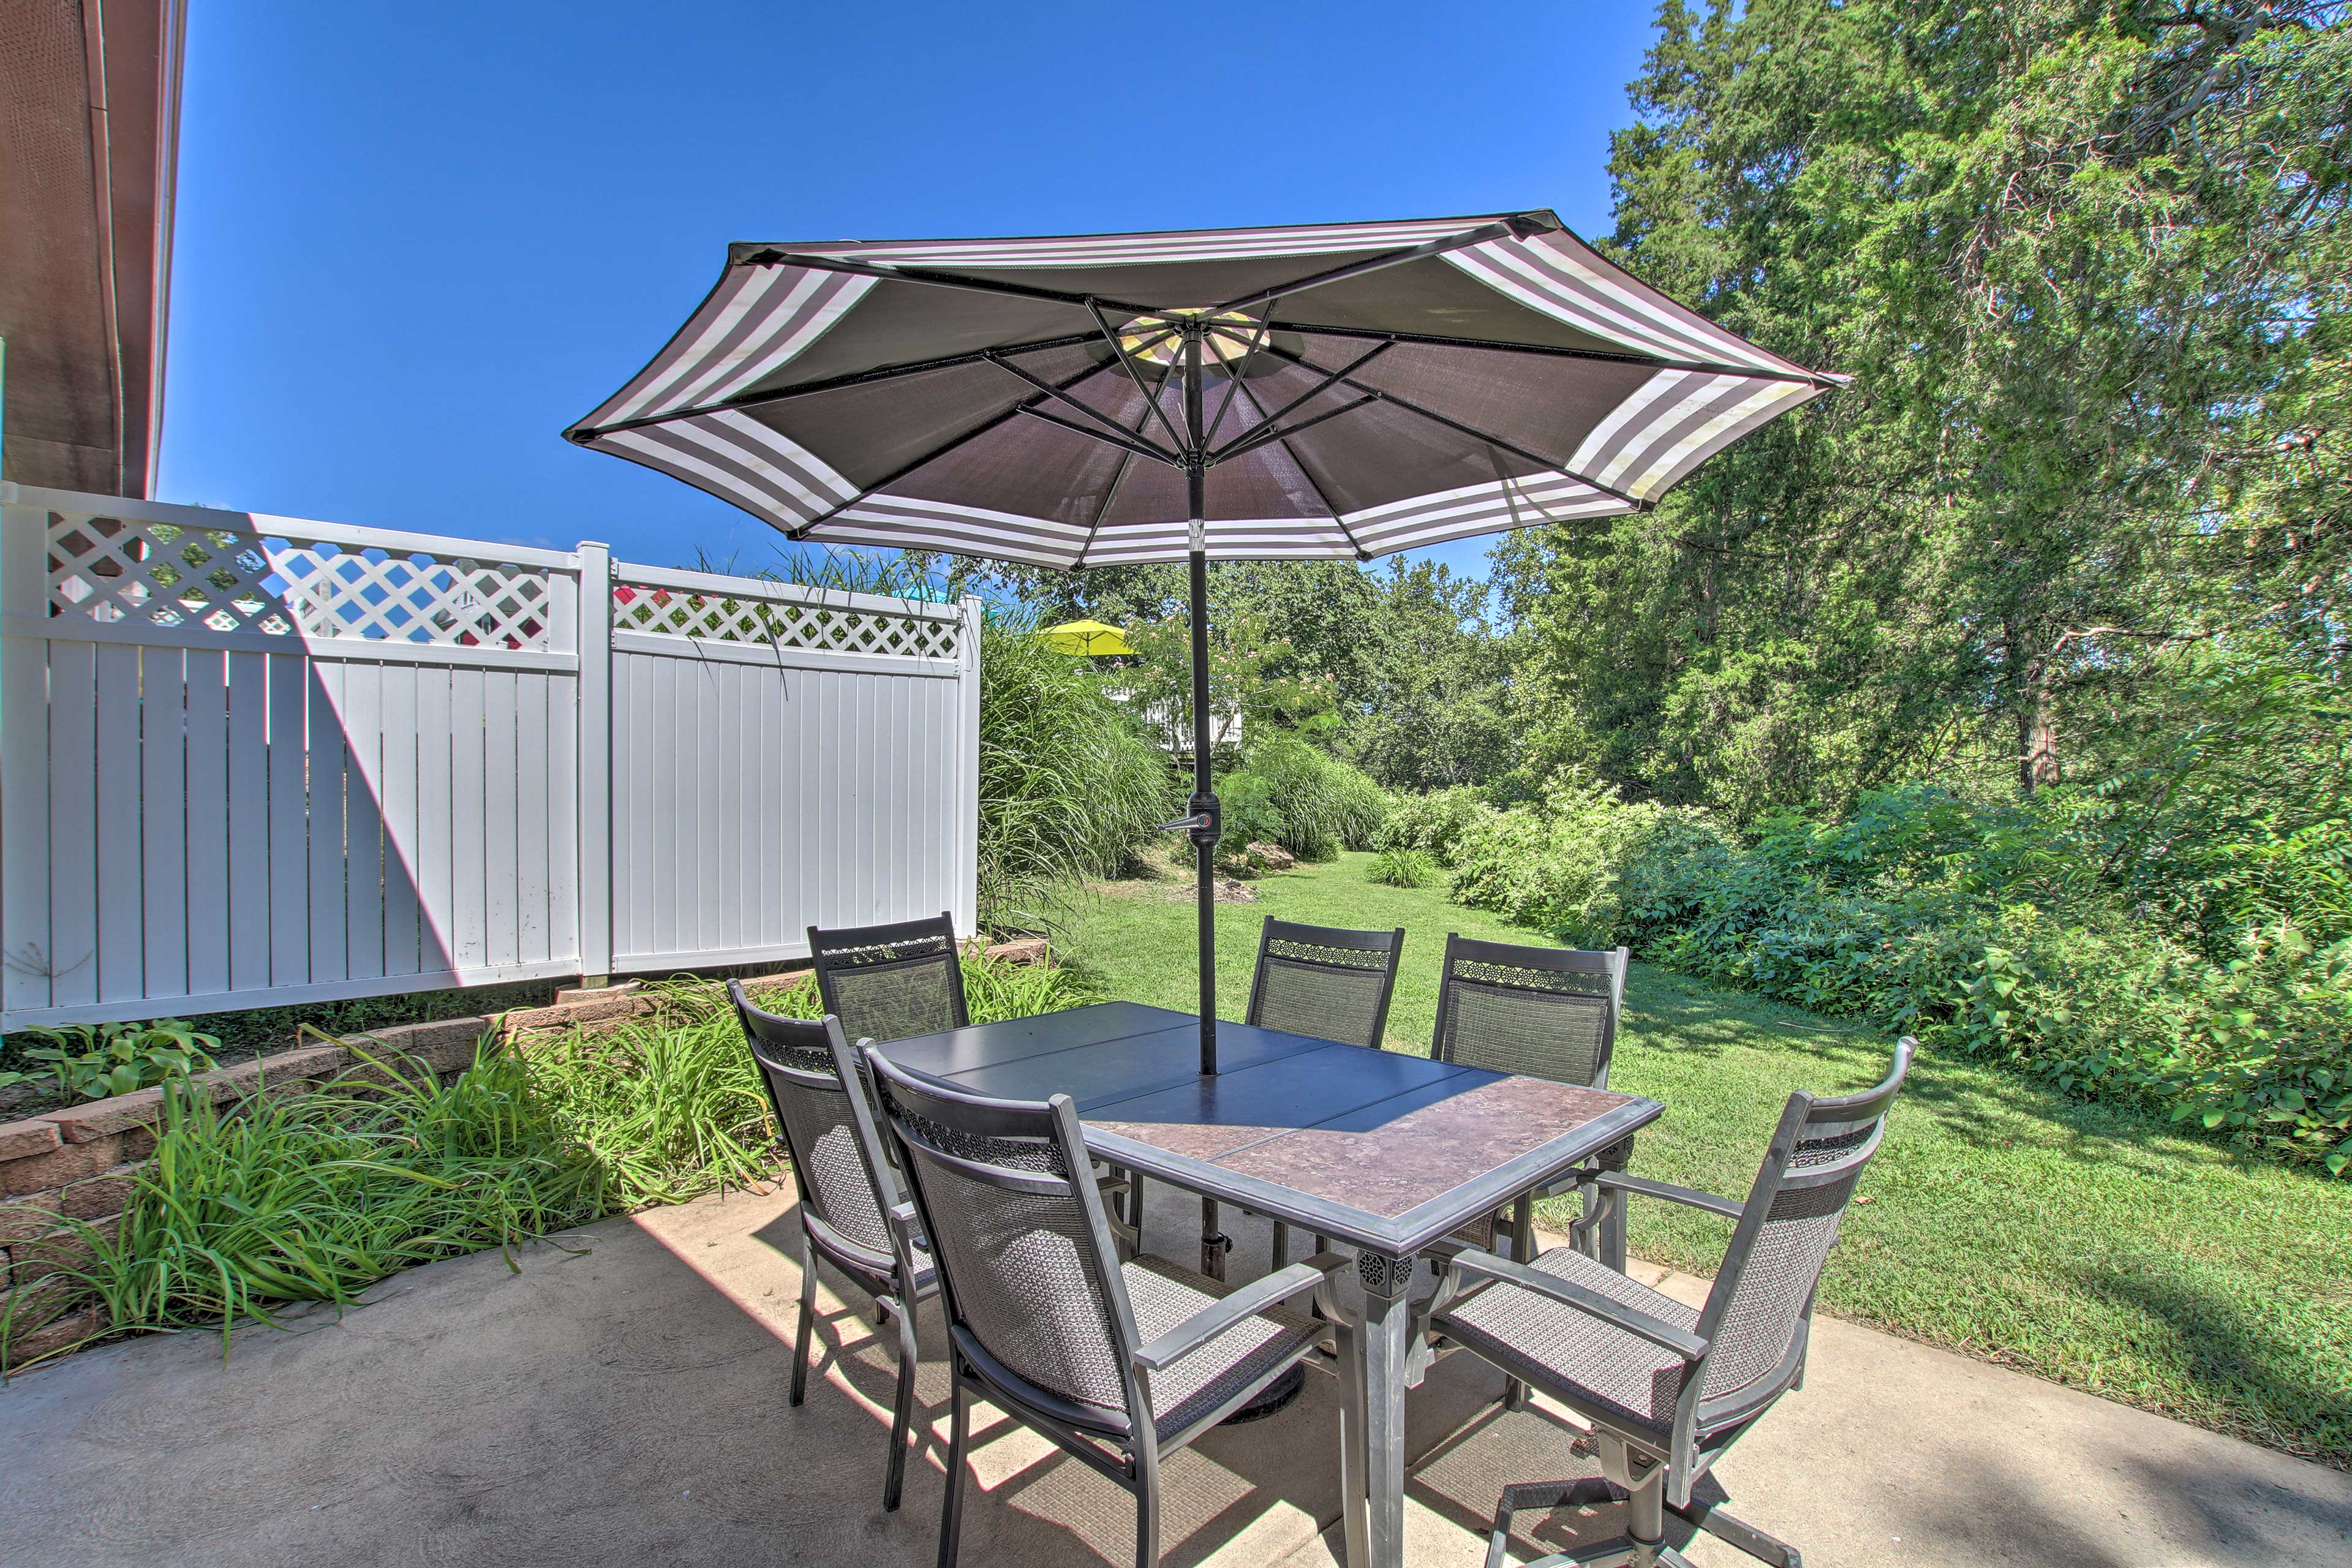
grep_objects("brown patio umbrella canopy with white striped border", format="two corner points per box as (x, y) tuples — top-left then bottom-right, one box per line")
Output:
(565, 211), (1834, 569)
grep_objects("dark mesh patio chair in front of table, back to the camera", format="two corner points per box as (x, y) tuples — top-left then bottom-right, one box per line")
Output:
(865, 1046), (1345, 1568)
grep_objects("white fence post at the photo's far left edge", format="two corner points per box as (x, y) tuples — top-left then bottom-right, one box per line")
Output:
(0, 484), (50, 1011)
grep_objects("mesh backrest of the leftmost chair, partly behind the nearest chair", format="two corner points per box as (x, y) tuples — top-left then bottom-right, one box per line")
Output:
(727, 980), (899, 1272)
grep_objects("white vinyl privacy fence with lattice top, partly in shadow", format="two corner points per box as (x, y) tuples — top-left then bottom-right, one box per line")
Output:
(0, 484), (978, 1027)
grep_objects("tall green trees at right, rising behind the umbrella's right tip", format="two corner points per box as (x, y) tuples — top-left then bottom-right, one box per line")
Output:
(1498, 0), (2352, 820)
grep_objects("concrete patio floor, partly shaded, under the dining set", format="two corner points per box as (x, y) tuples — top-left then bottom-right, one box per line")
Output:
(0, 1187), (2352, 1568)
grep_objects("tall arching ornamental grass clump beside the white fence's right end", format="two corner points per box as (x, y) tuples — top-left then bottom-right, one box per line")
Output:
(981, 618), (1178, 931)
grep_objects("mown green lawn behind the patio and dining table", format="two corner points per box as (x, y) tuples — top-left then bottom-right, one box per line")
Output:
(1063, 856), (2352, 1469)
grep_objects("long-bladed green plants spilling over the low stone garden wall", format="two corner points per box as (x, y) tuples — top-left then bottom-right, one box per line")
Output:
(0, 959), (1091, 1371)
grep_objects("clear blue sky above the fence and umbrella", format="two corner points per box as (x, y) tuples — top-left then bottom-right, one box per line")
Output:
(160, 0), (1651, 582)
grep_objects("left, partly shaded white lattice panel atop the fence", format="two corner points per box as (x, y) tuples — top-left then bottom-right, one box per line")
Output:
(50, 513), (562, 649)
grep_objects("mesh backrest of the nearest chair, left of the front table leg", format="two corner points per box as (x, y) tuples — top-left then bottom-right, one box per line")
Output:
(865, 1046), (1140, 1430)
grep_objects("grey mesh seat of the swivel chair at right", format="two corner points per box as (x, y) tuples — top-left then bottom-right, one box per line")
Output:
(1434, 1246), (1698, 1436)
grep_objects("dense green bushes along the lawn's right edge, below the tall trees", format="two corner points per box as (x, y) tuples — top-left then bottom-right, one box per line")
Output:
(1616, 785), (2352, 1173)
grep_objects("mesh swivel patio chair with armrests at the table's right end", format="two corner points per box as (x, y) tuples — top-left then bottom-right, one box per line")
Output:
(1430, 1039), (1917, 1568)
